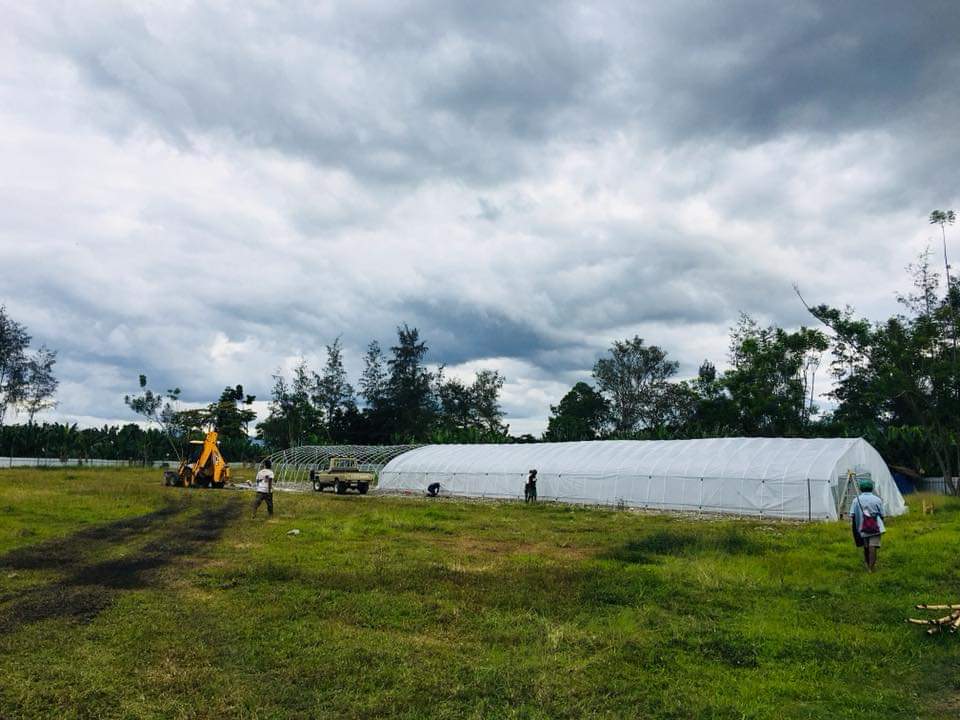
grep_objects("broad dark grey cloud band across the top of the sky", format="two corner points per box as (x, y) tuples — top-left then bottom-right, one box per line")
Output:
(31, 2), (960, 188)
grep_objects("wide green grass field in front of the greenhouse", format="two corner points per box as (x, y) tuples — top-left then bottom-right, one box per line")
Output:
(0, 470), (960, 720)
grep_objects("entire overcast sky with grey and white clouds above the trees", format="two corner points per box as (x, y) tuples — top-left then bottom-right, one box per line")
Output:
(0, 0), (960, 433)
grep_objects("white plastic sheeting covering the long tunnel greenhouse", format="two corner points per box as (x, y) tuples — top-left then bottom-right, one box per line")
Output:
(379, 438), (906, 520)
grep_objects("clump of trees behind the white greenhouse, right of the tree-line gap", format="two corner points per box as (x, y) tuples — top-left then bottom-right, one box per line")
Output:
(544, 211), (960, 493)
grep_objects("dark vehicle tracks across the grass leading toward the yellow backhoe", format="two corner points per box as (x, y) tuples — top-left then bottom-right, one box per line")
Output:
(0, 498), (242, 633)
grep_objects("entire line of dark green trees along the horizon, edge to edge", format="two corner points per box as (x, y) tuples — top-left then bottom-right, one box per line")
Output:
(0, 211), (960, 492)
